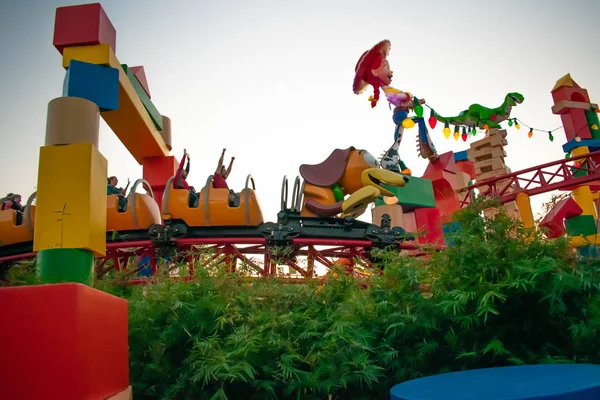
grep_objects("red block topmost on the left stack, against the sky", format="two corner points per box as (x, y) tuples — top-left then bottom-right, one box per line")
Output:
(53, 3), (117, 54)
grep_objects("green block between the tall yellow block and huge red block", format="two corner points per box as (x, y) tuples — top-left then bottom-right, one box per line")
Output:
(36, 248), (94, 285)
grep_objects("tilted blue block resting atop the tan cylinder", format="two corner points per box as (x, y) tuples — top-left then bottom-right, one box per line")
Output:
(63, 60), (119, 112)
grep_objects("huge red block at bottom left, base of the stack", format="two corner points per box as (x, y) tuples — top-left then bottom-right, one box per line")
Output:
(0, 283), (129, 400)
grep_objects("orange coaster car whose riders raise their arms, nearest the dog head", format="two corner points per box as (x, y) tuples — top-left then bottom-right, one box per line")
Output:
(163, 175), (264, 226)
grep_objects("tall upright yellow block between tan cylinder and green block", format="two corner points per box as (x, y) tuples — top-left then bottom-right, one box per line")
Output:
(33, 143), (107, 257)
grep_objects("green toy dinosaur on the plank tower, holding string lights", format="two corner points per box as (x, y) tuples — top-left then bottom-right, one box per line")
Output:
(435, 92), (525, 129)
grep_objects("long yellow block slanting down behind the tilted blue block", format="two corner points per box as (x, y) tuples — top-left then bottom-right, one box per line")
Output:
(63, 44), (169, 165)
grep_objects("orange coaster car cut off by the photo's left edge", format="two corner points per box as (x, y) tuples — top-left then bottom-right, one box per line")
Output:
(0, 193), (36, 246)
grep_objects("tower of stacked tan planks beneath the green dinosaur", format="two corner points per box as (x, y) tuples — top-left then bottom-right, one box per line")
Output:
(467, 128), (518, 217)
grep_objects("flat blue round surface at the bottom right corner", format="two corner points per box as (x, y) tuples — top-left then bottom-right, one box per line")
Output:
(390, 364), (600, 400)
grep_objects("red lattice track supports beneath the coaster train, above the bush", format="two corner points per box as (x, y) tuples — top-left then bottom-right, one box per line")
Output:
(0, 237), (444, 284)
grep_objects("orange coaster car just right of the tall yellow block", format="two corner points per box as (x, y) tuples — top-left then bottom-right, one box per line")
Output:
(106, 179), (162, 232)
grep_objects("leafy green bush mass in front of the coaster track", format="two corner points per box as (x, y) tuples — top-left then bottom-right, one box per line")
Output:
(1, 208), (600, 400)
